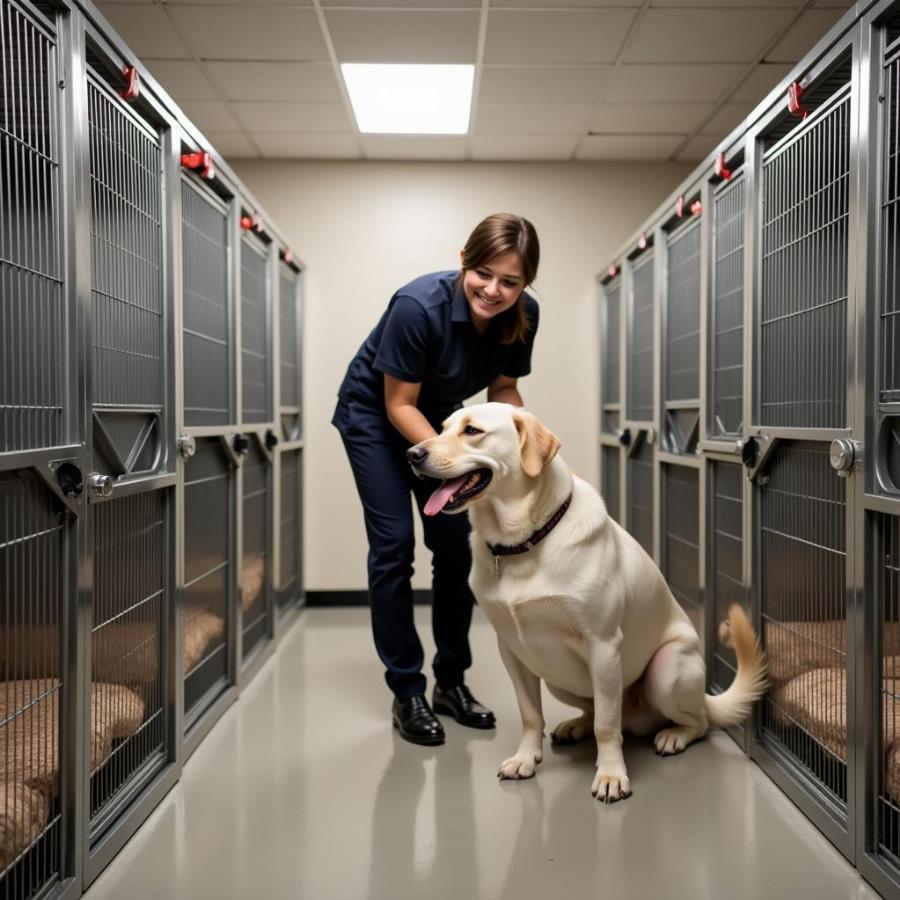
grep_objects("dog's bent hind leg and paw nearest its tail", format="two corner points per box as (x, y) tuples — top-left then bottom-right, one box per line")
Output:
(644, 636), (709, 756)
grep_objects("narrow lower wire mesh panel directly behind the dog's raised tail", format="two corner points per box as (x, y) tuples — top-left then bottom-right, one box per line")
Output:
(706, 460), (745, 690)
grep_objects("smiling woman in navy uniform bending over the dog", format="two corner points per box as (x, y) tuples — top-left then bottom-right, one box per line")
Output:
(332, 214), (540, 745)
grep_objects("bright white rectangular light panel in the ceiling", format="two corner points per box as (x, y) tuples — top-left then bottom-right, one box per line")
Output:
(341, 63), (475, 134)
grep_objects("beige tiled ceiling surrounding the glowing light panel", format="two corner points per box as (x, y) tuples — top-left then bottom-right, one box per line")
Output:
(98, 0), (852, 162)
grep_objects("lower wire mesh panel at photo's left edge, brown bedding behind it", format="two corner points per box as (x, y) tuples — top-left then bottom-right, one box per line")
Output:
(0, 471), (67, 900)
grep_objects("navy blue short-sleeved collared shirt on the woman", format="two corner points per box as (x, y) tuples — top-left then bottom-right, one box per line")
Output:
(335, 270), (538, 424)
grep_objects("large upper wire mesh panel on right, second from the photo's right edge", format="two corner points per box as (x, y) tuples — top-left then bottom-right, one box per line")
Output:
(759, 85), (850, 428)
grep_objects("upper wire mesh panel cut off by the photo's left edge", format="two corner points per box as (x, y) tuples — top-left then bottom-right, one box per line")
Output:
(0, 0), (67, 453)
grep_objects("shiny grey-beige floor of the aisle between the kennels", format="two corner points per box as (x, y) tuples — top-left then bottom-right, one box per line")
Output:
(85, 608), (877, 900)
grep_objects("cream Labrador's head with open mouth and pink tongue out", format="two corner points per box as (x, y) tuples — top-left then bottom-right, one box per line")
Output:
(406, 403), (559, 516)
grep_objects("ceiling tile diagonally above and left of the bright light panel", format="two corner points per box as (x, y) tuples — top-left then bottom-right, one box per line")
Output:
(168, 6), (328, 61)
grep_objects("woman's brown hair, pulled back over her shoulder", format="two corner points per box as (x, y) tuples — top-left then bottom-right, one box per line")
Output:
(457, 213), (541, 344)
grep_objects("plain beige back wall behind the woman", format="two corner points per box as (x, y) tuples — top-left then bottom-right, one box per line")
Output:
(235, 160), (691, 590)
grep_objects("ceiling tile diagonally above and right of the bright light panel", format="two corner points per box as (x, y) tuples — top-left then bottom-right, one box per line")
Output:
(484, 9), (635, 65)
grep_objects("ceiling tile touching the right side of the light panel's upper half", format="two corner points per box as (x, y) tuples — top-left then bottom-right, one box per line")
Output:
(478, 66), (612, 103)
